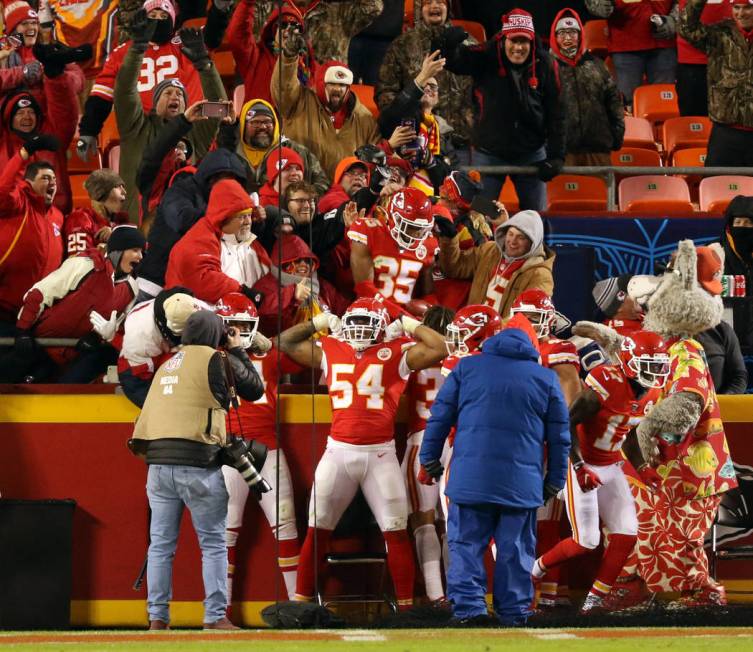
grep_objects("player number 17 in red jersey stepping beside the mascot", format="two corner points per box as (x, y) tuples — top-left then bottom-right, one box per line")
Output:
(532, 331), (670, 613)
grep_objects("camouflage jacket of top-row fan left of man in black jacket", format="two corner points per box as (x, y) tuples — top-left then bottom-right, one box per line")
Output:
(375, 1), (476, 147)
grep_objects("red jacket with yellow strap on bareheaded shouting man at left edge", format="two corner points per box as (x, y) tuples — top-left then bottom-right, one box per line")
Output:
(0, 154), (63, 321)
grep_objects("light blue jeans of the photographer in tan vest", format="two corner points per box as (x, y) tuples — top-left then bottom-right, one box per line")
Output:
(146, 464), (228, 623)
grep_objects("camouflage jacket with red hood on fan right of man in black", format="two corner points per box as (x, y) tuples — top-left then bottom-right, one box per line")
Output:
(549, 9), (625, 154)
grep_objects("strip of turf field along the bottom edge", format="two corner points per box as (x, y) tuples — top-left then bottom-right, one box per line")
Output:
(0, 627), (753, 652)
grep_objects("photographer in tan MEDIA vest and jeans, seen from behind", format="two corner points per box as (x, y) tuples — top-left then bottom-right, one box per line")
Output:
(129, 310), (264, 630)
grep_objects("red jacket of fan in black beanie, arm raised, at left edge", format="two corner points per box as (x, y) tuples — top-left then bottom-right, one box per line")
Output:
(0, 79), (78, 214)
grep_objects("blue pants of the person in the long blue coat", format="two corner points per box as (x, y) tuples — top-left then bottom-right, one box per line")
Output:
(447, 502), (536, 627)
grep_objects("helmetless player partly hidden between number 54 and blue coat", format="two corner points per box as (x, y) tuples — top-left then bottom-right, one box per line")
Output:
(402, 306), (454, 605)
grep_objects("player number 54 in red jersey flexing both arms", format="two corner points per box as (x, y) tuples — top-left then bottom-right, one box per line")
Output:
(279, 298), (446, 609)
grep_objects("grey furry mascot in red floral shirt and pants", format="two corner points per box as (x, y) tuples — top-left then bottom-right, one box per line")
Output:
(574, 240), (737, 609)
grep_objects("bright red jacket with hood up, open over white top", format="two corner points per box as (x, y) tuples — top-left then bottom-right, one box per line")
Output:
(165, 179), (253, 303)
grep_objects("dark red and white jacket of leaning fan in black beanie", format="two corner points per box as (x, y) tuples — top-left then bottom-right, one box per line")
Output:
(16, 249), (136, 337)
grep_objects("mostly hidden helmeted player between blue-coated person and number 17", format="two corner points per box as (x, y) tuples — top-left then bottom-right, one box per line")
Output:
(511, 288), (581, 609)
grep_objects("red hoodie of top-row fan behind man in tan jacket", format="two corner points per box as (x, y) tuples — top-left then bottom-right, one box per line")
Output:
(227, 0), (316, 103)
